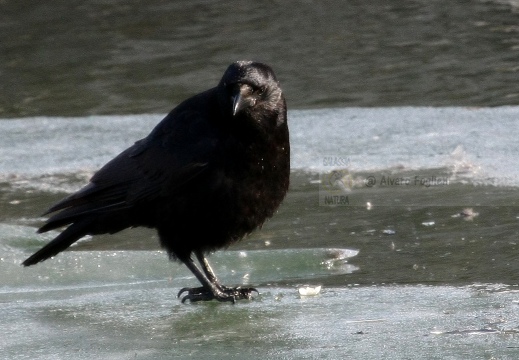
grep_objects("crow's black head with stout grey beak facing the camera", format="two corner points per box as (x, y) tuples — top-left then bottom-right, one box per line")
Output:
(218, 61), (285, 124)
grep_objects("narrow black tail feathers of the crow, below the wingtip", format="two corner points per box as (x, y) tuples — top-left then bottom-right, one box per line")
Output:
(22, 221), (90, 266)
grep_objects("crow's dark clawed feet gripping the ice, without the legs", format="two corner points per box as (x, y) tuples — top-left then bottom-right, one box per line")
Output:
(177, 286), (259, 303)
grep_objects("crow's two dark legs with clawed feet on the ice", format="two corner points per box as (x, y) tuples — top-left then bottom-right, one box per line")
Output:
(178, 252), (258, 303)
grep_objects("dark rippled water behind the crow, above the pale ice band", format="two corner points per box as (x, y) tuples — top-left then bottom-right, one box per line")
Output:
(0, 0), (519, 117)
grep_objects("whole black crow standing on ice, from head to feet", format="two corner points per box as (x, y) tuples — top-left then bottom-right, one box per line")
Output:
(23, 61), (290, 301)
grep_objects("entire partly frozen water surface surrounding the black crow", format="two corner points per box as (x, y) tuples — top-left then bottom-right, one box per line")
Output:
(0, 0), (519, 360)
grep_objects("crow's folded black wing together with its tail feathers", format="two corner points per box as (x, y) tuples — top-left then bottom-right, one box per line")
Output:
(23, 98), (218, 266)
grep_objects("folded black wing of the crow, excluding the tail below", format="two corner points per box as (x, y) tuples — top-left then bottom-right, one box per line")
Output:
(38, 111), (216, 232)
